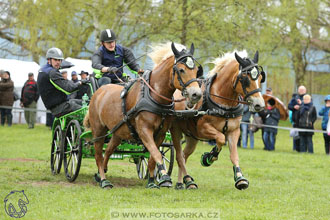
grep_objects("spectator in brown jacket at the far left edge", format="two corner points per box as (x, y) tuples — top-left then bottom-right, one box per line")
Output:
(0, 71), (14, 127)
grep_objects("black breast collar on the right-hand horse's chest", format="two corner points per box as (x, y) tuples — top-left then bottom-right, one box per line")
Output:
(199, 74), (244, 118)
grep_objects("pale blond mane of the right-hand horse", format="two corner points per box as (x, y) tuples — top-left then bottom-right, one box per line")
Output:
(207, 50), (247, 78)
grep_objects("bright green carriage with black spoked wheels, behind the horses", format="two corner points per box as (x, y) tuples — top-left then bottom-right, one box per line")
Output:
(50, 78), (174, 182)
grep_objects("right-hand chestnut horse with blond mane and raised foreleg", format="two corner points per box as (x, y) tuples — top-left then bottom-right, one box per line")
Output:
(164, 49), (265, 190)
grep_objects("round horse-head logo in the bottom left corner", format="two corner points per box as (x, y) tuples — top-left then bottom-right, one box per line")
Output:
(4, 190), (29, 218)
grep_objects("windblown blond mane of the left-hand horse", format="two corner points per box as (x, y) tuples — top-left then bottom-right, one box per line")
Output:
(148, 42), (186, 68)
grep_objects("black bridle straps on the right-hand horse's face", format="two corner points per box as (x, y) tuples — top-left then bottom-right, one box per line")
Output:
(234, 62), (261, 101)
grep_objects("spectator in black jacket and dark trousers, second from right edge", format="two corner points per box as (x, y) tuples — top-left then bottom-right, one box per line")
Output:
(297, 94), (317, 153)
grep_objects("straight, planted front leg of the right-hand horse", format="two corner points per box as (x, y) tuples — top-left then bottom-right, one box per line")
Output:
(228, 128), (249, 190)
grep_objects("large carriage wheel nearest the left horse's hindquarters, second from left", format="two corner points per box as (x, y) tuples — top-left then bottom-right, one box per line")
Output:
(63, 120), (83, 182)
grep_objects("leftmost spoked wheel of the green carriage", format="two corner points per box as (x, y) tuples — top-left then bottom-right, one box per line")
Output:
(50, 125), (63, 175)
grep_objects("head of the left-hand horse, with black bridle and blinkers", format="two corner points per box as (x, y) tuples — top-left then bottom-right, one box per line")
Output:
(171, 42), (203, 106)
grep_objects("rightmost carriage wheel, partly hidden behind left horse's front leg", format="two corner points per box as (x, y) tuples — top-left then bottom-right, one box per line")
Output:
(154, 143), (174, 181)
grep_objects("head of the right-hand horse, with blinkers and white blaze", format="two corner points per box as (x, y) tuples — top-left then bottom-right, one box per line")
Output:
(234, 51), (266, 112)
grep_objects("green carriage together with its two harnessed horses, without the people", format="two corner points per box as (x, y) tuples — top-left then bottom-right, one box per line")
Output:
(51, 43), (265, 189)
